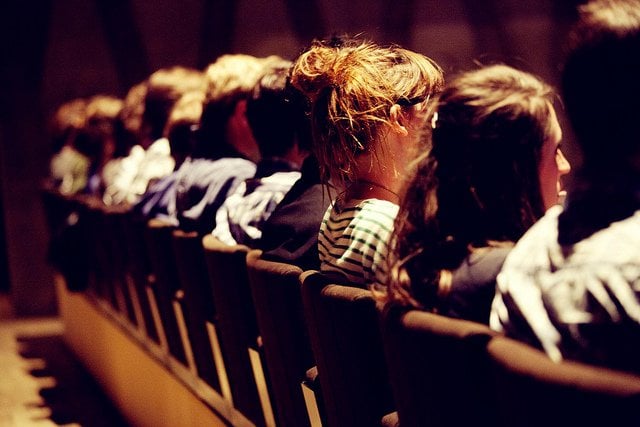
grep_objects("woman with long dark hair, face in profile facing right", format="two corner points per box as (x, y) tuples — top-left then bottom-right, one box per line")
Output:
(379, 65), (569, 324)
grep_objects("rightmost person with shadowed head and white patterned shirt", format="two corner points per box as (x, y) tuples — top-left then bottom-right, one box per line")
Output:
(491, 0), (640, 373)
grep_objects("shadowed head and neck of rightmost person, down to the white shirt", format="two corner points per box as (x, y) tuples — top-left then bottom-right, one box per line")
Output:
(558, 0), (640, 246)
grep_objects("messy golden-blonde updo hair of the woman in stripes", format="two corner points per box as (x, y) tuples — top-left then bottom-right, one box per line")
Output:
(291, 39), (444, 186)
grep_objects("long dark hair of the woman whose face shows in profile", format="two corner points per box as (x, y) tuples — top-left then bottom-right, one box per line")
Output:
(390, 65), (553, 305)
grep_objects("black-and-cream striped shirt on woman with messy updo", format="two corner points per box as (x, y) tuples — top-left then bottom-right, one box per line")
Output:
(318, 199), (398, 287)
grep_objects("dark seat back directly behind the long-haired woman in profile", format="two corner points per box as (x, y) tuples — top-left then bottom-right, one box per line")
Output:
(380, 307), (497, 427)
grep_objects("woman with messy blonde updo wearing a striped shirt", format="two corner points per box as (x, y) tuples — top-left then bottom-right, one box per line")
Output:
(291, 36), (443, 287)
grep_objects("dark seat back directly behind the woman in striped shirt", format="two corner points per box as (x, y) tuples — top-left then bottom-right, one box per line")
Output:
(301, 271), (394, 427)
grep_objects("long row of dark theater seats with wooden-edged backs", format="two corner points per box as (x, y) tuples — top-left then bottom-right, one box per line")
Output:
(43, 191), (640, 427)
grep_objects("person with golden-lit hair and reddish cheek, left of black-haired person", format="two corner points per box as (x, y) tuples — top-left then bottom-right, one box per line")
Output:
(137, 54), (281, 234)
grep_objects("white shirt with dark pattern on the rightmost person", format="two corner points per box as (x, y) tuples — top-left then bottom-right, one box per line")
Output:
(490, 206), (640, 371)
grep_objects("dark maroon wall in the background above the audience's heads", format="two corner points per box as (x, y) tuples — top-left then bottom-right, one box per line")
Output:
(0, 0), (581, 316)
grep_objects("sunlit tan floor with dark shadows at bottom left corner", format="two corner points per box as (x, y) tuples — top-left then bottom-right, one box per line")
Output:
(0, 295), (127, 427)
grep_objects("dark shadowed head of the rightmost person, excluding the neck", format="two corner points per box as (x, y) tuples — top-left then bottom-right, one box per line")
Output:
(562, 0), (640, 168)
